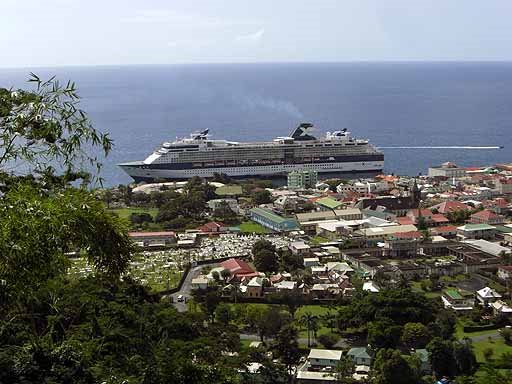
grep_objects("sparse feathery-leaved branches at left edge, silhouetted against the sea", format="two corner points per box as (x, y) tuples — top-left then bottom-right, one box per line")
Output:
(0, 74), (112, 182)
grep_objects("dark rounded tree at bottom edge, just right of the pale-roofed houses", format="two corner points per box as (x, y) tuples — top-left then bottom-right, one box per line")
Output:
(373, 349), (416, 384)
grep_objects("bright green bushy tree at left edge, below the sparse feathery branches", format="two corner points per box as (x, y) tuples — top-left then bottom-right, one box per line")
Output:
(0, 183), (134, 291)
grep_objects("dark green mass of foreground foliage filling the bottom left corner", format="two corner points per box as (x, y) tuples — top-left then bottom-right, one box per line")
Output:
(0, 277), (244, 384)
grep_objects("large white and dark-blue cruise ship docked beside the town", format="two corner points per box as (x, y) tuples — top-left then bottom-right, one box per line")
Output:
(119, 123), (384, 182)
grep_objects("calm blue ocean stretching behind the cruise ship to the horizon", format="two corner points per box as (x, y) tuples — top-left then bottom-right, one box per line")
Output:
(0, 62), (512, 186)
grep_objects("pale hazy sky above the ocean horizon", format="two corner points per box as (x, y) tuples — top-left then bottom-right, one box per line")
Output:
(0, 0), (512, 67)
